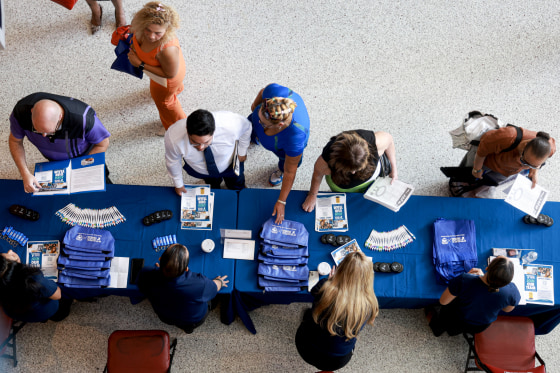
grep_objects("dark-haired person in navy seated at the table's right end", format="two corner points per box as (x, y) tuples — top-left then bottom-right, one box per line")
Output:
(428, 256), (521, 337)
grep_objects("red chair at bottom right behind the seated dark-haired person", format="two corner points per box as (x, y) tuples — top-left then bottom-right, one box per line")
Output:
(463, 316), (546, 373)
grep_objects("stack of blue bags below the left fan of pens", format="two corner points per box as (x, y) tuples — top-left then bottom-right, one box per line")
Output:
(58, 225), (115, 288)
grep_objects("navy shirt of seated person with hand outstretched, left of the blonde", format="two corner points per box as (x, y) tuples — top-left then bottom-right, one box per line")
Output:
(138, 267), (218, 325)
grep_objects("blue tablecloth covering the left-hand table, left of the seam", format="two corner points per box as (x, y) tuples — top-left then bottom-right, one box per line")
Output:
(0, 180), (237, 298)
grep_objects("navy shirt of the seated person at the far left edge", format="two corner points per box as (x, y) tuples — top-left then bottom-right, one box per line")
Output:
(3, 273), (58, 322)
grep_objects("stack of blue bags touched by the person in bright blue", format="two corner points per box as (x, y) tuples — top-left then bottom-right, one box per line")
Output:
(257, 218), (309, 292)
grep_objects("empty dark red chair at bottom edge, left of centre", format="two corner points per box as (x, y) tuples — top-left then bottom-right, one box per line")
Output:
(104, 330), (177, 373)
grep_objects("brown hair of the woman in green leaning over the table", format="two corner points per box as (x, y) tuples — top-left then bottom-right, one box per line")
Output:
(328, 131), (377, 185)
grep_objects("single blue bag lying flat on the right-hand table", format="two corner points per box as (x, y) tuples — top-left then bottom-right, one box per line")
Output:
(433, 218), (478, 285)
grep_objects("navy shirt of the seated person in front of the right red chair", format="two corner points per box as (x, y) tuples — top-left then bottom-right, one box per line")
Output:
(449, 273), (521, 325)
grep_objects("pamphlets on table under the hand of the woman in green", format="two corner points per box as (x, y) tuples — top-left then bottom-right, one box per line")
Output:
(315, 193), (348, 232)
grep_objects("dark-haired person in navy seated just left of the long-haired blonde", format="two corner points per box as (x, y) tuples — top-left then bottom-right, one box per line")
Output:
(138, 244), (229, 334)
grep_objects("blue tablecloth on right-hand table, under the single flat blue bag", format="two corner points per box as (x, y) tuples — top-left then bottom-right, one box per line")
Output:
(234, 189), (560, 334)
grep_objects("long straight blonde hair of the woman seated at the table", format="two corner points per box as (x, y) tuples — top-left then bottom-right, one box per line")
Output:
(312, 251), (379, 339)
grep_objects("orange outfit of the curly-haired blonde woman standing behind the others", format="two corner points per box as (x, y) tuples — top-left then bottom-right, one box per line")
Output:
(132, 35), (187, 129)
